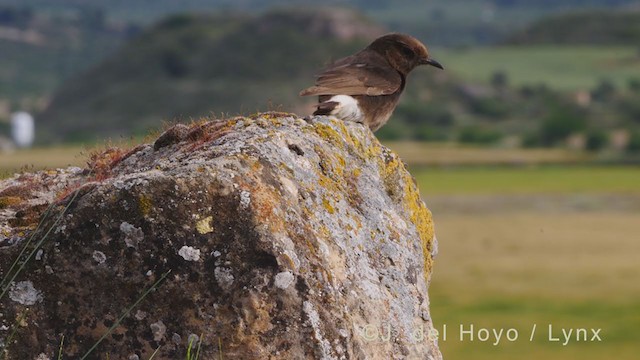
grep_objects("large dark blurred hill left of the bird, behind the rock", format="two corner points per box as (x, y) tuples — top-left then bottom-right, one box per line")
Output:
(39, 11), (382, 141)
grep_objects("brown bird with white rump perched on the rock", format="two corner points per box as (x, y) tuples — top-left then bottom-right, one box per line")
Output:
(300, 33), (444, 131)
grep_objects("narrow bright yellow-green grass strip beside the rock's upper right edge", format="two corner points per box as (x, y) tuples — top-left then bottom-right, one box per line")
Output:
(411, 166), (640, 195)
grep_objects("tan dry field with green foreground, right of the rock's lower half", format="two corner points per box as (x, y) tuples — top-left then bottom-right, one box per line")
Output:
(430, 210), (640, 360)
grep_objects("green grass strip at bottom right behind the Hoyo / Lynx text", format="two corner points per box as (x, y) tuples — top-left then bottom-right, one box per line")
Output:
(431, 293), (640, 360)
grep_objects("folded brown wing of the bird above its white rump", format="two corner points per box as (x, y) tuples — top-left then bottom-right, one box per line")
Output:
(300, 56), (402, 96)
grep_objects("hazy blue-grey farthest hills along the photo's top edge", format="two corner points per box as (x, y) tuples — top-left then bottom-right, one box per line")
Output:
(0, 0), (639, 45)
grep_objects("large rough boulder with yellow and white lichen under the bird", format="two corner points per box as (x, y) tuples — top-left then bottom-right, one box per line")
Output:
(0, 113), (441, 359)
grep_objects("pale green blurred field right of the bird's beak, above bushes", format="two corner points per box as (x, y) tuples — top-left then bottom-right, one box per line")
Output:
(432, 45), (640, 91)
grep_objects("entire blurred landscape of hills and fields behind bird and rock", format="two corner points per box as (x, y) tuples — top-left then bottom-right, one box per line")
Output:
(0, 0), (640, 359)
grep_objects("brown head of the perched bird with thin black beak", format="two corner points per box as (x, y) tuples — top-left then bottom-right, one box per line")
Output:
(368, 33), (444, 75)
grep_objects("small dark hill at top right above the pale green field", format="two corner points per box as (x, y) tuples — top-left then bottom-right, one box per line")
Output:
(506, 10), (640, 46)
